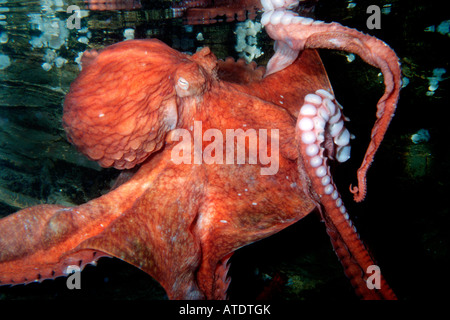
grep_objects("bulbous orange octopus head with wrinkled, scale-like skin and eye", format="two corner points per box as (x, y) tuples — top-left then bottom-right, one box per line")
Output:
(63, 39), (217, 169)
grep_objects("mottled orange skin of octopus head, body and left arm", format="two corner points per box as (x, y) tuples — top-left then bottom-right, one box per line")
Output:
(0, 40), (331, 299)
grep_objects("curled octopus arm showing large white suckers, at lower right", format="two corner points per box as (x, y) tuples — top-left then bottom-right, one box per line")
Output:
(296, 90), (395, 299)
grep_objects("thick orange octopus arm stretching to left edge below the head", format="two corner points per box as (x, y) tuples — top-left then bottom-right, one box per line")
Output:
(0, 149), (169, 285)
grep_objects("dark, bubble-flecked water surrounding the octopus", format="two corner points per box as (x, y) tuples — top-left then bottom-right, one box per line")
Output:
(0, 0), (450, 300)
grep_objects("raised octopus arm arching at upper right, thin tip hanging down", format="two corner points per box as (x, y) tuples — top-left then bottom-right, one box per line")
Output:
(261, 1), (401, 202)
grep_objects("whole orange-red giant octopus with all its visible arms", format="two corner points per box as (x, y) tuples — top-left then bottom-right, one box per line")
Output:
(0, 0), (401, 299)
